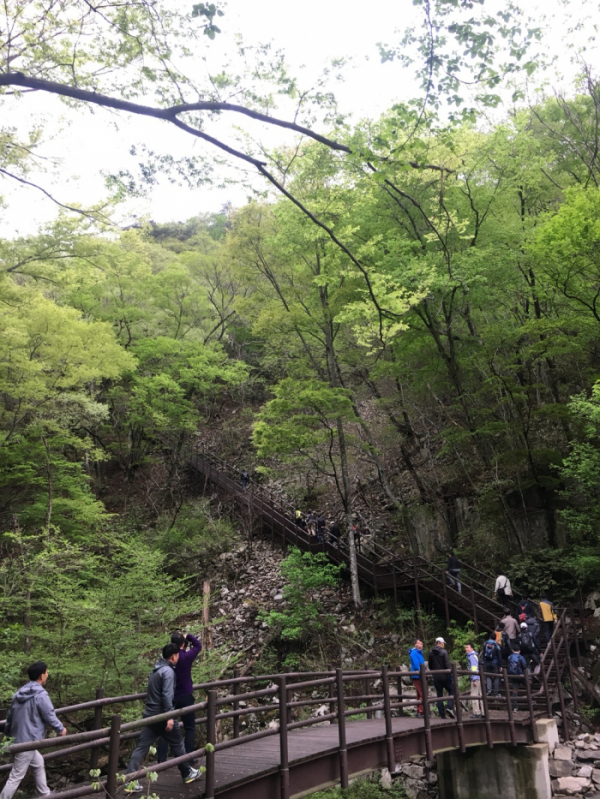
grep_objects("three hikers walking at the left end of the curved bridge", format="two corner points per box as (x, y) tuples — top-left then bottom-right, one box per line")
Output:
(0, 631), (202, 799)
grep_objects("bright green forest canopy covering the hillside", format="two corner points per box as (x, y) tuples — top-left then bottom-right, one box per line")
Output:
(0, 0), (600, 696)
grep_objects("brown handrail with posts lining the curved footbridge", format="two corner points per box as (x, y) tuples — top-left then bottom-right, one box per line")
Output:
(11, 663), (536, 799)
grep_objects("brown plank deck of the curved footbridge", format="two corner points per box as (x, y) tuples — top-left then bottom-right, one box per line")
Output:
(151, 712), (532, 799)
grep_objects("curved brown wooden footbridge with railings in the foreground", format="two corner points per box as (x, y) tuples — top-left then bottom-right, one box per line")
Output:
(0, 664), (538, 799)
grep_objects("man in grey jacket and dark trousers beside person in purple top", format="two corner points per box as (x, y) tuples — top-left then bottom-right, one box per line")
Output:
(124, 644), (199, 793)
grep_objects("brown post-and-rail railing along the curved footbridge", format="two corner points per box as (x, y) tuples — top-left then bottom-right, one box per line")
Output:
(0, 664), (544, 799)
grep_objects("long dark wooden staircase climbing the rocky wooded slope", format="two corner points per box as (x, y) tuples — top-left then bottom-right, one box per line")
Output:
(171, 439), (584, 720)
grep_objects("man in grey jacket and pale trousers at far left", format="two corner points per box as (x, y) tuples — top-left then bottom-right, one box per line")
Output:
(0, 660), (67, 799)
